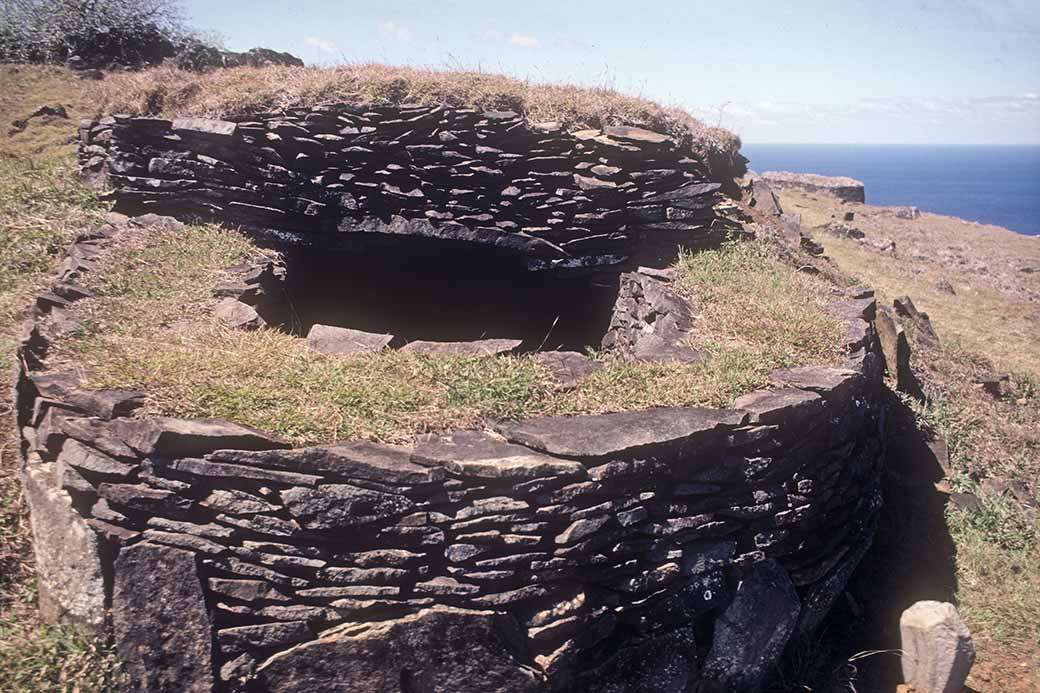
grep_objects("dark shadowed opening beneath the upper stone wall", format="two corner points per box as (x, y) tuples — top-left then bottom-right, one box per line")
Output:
(277, 239), (618, 352)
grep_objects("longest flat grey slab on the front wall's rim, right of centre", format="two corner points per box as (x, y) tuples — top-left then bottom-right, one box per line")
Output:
(495, 405), (748, 458)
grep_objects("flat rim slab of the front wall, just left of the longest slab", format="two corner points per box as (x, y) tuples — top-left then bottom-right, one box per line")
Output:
(413, 431), (586, 479)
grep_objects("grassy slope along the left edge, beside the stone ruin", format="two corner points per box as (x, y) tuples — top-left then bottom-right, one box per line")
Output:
(0, 66), (123, 693)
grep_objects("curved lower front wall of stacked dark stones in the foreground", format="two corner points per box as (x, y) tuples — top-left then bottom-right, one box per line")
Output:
(15, 218), (883, 693)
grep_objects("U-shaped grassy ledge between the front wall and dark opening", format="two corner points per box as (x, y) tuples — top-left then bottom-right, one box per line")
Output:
(48, 226), (843, 444)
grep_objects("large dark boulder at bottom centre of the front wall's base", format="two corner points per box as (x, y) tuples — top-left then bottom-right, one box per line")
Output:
(257, 607), (544, 693)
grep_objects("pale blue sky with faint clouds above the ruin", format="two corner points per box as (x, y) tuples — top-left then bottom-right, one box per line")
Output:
(182, 0), (1040, 145)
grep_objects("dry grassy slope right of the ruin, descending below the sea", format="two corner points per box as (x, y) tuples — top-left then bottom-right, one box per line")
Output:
(780, 190), (1040, 692)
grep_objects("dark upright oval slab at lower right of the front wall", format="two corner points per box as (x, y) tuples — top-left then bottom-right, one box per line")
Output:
(702, 560), (801, 692)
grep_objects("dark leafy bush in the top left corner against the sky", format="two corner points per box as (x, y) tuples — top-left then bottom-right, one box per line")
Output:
(0, 0), (185, 69)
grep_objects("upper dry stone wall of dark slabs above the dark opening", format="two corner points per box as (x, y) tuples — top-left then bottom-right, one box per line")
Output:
(80, 105), (744, 270)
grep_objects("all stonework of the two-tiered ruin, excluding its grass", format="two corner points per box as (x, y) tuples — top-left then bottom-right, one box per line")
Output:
(4, 93), (884, 693)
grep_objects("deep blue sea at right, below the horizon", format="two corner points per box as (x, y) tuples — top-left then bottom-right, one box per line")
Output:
(742, 145), (1040, 235)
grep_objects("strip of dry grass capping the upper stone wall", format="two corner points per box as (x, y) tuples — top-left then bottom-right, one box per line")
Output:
(95, 62), (740, 155)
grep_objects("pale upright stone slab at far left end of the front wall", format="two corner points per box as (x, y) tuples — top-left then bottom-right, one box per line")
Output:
(22, 463), (105, 633)
